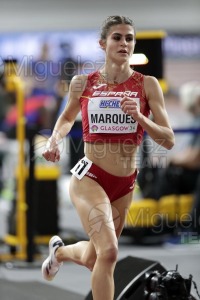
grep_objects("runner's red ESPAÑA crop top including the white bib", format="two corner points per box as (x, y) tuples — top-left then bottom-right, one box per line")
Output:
(80, 71), (150, 145)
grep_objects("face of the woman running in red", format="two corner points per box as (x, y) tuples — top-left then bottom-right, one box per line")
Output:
(101, 24), (135, 62)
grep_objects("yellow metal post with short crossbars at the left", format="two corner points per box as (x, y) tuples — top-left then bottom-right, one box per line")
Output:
(0, 61), (60, 262)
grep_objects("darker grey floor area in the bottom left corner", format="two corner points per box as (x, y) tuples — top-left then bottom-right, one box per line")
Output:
(0, 279), (84, 300)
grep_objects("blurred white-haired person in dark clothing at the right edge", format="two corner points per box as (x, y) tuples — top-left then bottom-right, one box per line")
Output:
(157, 82), (200, 198)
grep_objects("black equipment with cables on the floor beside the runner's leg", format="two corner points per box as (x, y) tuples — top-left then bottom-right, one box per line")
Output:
(85, 256), (199, 300)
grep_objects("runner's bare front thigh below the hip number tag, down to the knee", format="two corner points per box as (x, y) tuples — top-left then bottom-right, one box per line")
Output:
(69, 176), (117, 251)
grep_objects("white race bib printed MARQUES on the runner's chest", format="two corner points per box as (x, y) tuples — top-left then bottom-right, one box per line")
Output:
(88, 97), (140, 134)
